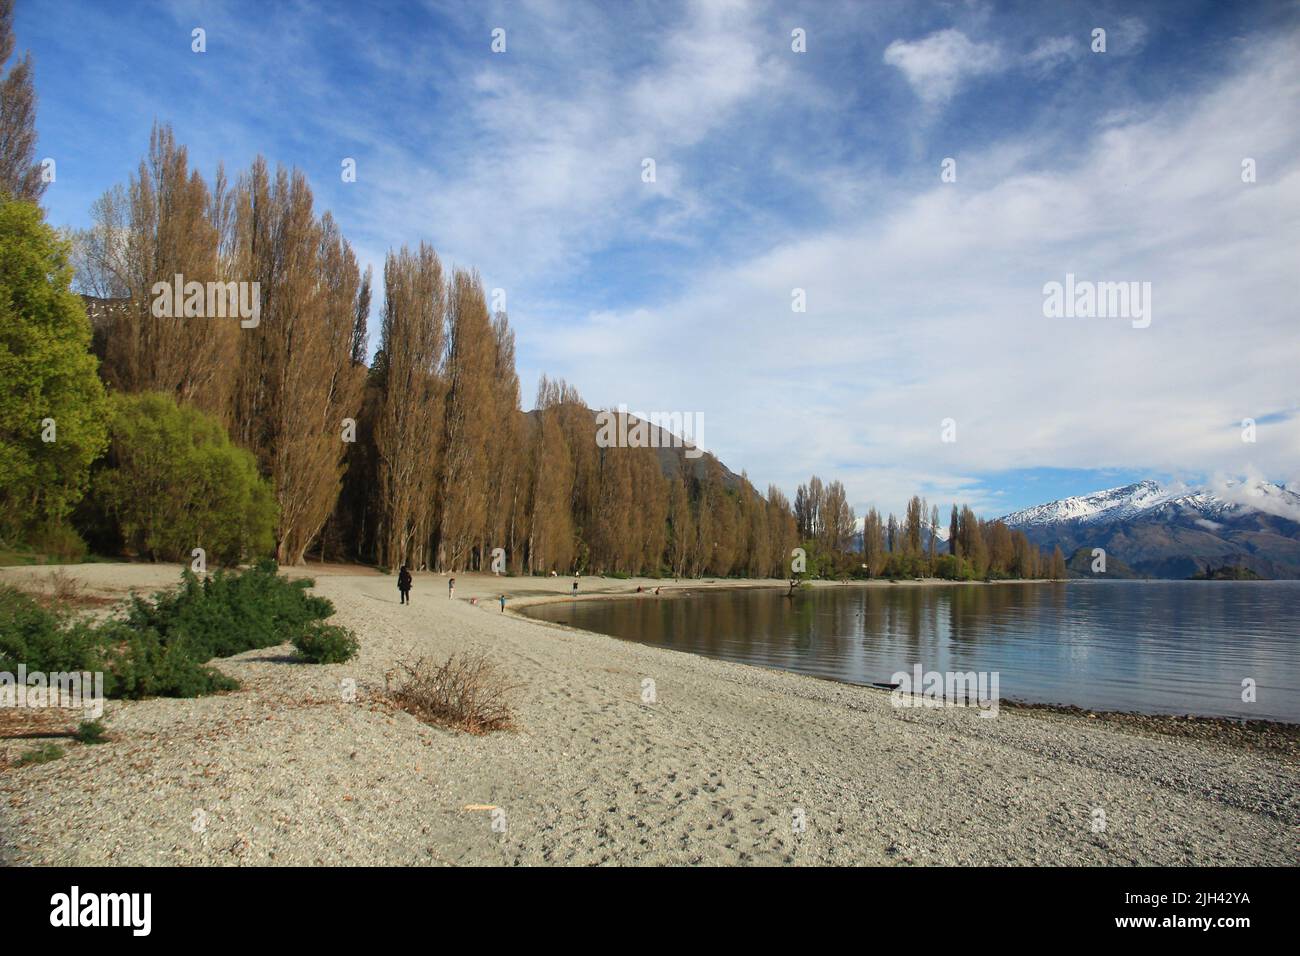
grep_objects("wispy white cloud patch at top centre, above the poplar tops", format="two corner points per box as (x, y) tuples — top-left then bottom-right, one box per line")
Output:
(348, 3), (798, 285)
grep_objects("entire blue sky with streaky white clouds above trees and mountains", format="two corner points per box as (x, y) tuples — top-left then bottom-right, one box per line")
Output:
(16, 0), (1300, 515)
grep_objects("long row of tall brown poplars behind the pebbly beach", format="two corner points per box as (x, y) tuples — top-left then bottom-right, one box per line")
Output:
(48, 119), (798, 576)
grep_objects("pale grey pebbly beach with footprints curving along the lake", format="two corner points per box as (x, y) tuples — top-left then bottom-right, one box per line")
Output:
(0, 564), (1300, 865)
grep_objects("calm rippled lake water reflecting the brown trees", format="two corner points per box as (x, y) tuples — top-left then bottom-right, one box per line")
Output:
(527, 581), (1300, 723)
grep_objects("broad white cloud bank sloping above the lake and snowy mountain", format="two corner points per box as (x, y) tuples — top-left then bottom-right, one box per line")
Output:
(538, 31), (1300, 510)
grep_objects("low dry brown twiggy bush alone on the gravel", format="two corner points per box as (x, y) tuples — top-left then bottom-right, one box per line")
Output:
(385, 654), (521, 734)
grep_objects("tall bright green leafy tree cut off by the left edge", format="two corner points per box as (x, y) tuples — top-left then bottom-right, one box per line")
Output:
(0, 200), (108, 536)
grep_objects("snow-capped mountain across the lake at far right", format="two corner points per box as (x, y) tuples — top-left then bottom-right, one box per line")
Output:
(1001, 479), (1300, 578)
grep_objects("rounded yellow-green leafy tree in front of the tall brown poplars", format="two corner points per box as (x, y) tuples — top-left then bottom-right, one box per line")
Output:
(94, 392), (278, 564)
